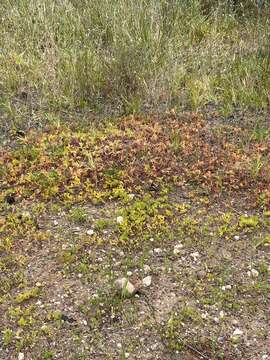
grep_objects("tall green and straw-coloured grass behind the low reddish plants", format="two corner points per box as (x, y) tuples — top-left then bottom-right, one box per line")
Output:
(0, 0), (270, 132)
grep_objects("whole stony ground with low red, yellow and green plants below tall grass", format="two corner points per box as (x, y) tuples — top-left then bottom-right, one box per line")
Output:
(0, 111), (270, 360)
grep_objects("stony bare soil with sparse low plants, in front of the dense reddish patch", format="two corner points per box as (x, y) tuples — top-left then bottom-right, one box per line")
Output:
(0, 111), (270, 360)
